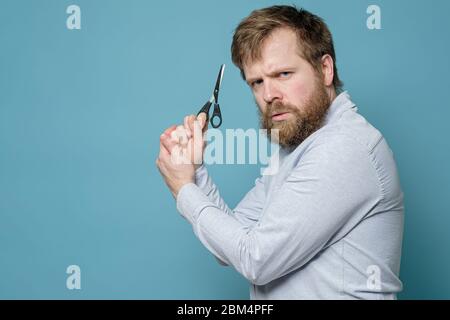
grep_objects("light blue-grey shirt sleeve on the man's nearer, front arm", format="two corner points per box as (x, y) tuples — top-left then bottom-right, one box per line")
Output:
(177, 135), (380, 285)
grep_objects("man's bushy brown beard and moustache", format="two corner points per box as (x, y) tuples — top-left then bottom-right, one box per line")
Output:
(258, 79), (331, 149)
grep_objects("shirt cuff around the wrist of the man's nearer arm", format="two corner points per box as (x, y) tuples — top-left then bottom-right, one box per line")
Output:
(177, 182), (211, 225)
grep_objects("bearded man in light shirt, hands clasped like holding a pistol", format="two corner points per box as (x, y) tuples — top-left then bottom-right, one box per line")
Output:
(156, 6), (404, 299)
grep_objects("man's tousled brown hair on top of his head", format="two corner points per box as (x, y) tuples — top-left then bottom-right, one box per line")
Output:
(231, 6), (343, 92)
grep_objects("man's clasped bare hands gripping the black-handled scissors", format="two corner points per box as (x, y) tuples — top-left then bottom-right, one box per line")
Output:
(156, 113), (207, 199)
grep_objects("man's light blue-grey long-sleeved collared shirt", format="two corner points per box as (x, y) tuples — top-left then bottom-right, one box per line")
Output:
(177, 92), (404, 299)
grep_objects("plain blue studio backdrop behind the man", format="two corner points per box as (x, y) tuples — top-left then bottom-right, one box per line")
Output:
(0, 0), (450, 299)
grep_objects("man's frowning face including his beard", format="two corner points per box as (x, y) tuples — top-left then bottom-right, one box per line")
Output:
(244, 28), (331, 148)
